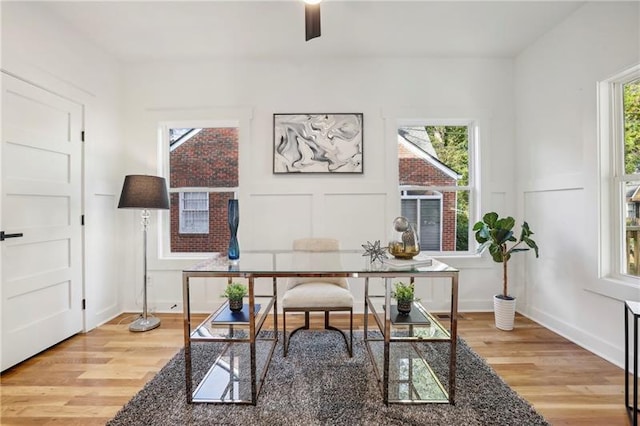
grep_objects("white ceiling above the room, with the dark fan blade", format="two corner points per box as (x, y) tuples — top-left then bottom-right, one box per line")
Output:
(43, 0), (583, 62)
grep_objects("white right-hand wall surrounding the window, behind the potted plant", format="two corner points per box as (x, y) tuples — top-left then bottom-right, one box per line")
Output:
(515, 2), (640, 365)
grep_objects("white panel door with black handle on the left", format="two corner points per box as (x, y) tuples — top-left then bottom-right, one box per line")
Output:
(0, 73), (83, 370)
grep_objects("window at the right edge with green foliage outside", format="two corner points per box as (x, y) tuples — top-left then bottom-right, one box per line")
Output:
(599, 65), (640, 297)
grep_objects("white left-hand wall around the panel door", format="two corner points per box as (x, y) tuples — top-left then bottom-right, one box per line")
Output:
(2, 2), (122, 329)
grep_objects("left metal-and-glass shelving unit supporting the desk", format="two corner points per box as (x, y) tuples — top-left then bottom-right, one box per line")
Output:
(183, 271), (278, 405)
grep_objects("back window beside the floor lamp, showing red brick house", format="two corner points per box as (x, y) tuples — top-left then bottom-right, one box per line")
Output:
(161, 123), (239, 253)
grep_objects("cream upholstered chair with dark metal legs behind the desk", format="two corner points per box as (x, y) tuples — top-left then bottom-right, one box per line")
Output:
(282, 238), (353, 356)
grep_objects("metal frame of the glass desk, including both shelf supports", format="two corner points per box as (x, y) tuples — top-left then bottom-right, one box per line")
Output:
(182, 258), (458, 405)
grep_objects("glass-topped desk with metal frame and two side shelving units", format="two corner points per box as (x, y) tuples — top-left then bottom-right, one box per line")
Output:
(182, 252), (458, 405)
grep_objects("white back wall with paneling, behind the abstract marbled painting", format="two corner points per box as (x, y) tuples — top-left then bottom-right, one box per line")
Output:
(123, 57), (515, 311)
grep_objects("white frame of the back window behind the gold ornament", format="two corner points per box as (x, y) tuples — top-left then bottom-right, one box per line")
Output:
(393, 118), (480, 257)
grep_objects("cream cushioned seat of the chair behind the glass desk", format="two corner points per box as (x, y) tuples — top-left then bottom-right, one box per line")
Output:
(282, 282), (353, 309)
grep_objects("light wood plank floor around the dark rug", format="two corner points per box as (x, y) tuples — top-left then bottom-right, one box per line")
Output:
(0, 313), (629, 426)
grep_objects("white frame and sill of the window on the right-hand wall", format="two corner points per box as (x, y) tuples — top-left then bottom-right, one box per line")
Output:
(587, 64), (640, 300)
